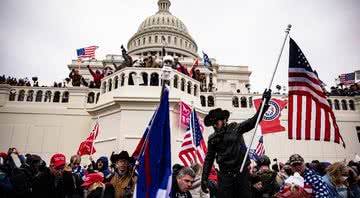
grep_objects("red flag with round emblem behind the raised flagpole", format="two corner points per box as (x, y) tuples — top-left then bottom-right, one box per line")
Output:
(254, 98), (287, 135)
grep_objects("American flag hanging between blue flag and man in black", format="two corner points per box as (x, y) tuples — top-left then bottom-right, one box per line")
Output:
(179, 110), (207, 166)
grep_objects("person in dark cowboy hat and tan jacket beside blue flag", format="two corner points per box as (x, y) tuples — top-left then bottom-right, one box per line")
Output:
(110, 151), (137, 198)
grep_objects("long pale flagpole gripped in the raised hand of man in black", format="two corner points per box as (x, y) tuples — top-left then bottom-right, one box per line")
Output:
(240, 24), (291, 173)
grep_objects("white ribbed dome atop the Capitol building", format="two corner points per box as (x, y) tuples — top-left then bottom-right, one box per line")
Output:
(127, 0), (198, 58)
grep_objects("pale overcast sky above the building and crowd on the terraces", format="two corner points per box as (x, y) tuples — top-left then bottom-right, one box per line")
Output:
(0, 0), (360, 91)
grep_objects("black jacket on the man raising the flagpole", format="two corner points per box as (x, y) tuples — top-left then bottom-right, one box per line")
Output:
(202, 105), (269, 179)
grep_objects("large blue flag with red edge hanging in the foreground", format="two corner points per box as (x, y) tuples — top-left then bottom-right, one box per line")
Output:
(134, 88), (171, 198)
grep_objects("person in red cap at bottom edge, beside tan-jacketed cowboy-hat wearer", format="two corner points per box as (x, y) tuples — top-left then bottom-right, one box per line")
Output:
(81, 173), (115, 198)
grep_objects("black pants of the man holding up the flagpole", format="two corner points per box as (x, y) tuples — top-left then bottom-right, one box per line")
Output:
(216, 168), (251, 198)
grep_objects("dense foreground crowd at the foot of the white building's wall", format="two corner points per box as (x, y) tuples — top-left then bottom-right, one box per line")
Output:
(0, 148), (360, 198)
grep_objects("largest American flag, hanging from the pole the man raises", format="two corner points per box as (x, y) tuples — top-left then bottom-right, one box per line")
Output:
(288, 38), (345, 147)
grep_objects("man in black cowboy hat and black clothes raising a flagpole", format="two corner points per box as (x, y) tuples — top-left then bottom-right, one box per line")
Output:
(201, 90), (271, 198)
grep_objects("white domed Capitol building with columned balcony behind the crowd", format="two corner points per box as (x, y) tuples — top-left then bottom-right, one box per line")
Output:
(0, 0), (360, 163)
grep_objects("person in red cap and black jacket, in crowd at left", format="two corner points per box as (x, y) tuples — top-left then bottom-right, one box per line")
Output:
(32, 153), (78, 198)
